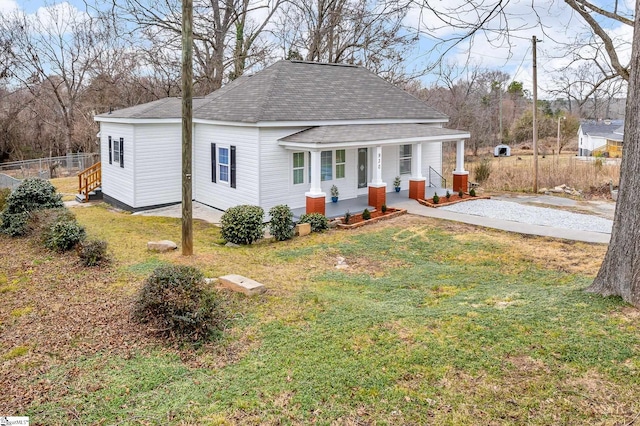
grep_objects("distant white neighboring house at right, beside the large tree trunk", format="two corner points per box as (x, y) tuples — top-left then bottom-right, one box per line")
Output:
(578, 120), (624, 157)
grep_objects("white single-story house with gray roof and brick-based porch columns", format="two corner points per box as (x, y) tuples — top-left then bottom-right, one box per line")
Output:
(95, 61), (469, 213)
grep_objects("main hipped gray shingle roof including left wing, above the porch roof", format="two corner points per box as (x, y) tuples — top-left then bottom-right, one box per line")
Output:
(100, 61), (447, 123)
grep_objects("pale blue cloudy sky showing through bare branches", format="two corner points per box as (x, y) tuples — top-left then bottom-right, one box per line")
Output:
(0, 0), (635, 97)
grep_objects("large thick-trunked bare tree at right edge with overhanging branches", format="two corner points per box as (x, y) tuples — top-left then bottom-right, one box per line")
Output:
(416, 0), (640, 306)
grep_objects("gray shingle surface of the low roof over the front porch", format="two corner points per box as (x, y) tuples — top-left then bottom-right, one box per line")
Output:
(280, 123), (469, 144)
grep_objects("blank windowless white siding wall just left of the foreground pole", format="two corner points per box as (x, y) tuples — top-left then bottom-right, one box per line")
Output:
(134, 123), (182, 207)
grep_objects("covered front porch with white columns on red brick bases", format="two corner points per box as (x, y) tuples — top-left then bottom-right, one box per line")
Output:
(278, 123), (470, 217)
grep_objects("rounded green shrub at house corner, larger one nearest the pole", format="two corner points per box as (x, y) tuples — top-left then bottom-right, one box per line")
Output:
(221, 205), (264, 244)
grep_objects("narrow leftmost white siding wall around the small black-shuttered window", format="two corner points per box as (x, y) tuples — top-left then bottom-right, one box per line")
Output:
(100, 122), (135, 207)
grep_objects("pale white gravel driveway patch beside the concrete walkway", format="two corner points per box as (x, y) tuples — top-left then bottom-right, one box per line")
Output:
(439, 200), (613, 233)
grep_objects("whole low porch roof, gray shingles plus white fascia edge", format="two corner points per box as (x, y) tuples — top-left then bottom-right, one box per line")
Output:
(278, 123), (470, 149)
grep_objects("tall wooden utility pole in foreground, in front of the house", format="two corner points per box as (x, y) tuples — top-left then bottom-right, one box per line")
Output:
(182, 0), (193, 256)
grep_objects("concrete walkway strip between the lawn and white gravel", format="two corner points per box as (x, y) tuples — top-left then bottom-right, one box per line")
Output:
(393, 200), (611, 244)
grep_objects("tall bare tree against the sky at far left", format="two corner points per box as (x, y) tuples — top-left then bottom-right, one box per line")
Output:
(0, 3), (110, 153)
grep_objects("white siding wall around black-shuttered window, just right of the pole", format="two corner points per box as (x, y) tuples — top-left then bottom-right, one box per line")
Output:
(193, 124), (260, 210)
